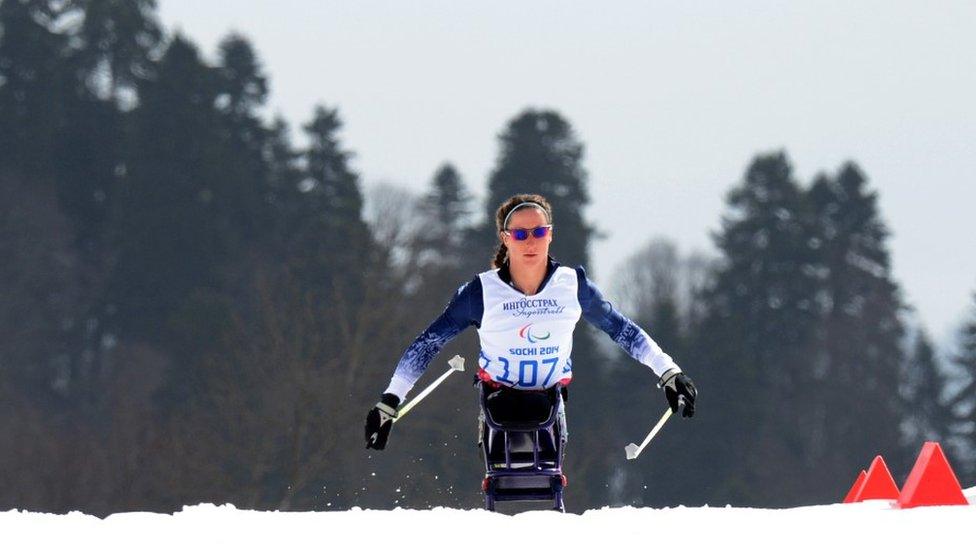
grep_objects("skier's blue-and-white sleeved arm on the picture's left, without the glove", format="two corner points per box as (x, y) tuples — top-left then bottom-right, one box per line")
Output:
(385, 276), (484, 402)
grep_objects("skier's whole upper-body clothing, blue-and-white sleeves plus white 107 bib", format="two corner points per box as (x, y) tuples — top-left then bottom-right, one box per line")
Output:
(386, 258), (681, 401)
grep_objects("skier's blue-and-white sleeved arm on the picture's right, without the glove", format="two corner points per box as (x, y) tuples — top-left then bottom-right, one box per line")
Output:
(576, 267), (681, 377)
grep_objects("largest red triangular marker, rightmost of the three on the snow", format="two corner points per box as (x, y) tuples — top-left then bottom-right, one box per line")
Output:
(898, 442), (969, 509)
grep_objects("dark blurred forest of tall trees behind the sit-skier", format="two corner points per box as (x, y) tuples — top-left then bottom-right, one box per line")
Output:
(0, 0), (976, 515)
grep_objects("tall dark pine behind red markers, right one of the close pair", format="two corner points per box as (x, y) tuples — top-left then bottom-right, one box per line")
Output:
(809, 163), (905, 488)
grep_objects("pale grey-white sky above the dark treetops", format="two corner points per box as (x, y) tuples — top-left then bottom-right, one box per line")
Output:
(159, 0), (976, 347)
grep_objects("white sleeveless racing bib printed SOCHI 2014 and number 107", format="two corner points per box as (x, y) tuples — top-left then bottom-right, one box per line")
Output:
(478, 266), (582, 389)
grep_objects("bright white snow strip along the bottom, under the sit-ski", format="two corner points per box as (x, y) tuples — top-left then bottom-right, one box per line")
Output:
(0, 488), (976, 549)
